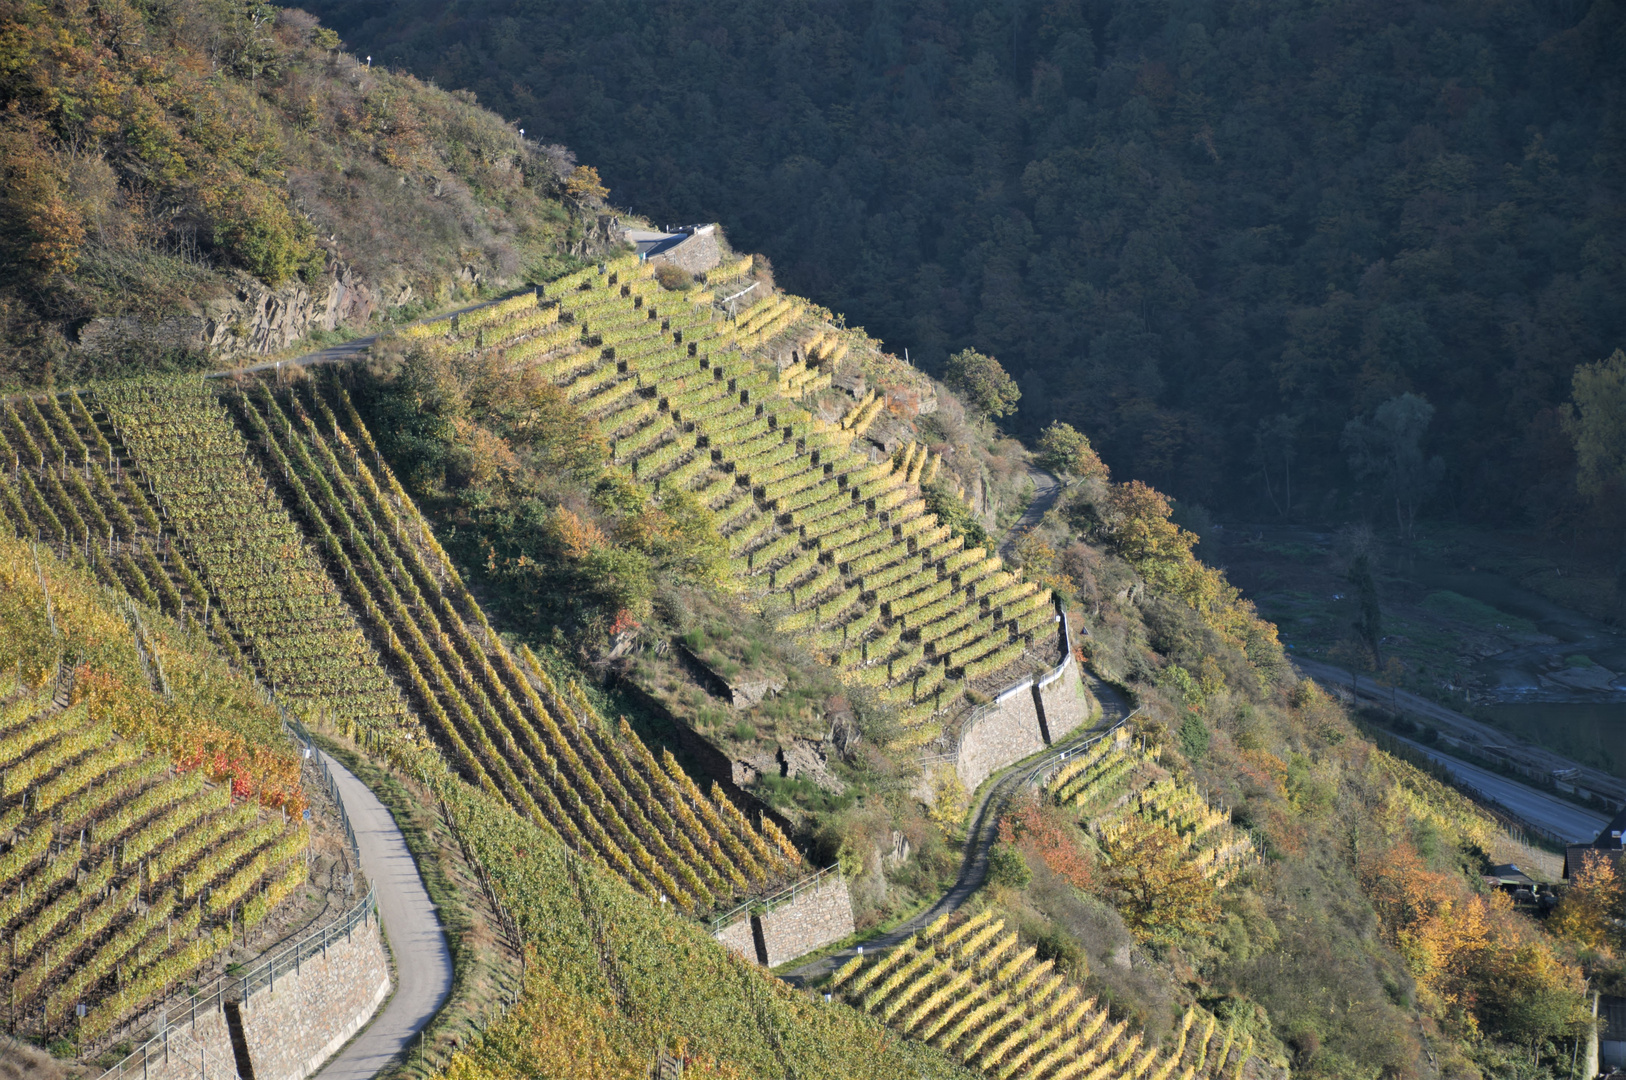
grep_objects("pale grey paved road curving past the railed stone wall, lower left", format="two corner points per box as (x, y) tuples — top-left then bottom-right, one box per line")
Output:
(315, 755), (452, 1080)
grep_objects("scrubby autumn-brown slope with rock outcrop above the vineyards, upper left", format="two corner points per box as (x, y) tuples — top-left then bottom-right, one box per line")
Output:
(0, 0), (602, 387)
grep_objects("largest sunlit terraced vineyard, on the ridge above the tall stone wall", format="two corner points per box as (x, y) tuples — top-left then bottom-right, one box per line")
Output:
(404, 255), (1055, 743)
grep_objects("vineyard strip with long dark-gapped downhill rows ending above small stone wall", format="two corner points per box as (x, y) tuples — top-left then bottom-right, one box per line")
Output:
(231, 384), (802, 911)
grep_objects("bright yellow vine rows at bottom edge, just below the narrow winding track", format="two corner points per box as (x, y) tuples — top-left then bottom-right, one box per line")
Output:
(829, 911), (1252, 1080)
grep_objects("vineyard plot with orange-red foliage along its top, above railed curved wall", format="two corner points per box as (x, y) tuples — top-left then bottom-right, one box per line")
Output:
(0, 538), (309, 1041)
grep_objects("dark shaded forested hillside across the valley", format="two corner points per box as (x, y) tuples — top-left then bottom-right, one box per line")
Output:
(299, 0), (1626, 522)
